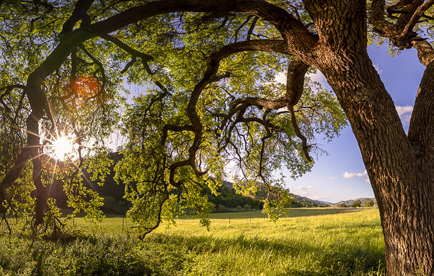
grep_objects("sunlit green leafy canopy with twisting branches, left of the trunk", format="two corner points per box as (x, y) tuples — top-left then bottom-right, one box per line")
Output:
(0, 0), (346, 237)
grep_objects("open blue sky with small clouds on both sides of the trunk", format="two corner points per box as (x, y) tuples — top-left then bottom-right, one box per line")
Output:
(284, 46), (425, 203)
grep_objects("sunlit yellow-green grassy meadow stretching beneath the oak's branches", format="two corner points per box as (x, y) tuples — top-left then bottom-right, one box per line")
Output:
(0, 208), (385, 276)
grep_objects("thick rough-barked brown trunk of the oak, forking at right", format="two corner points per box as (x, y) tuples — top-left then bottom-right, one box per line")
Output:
(304, 0), (434, 276)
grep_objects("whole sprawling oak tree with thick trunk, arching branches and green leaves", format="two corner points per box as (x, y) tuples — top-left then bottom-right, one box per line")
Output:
(0, 0), (434, 275)
